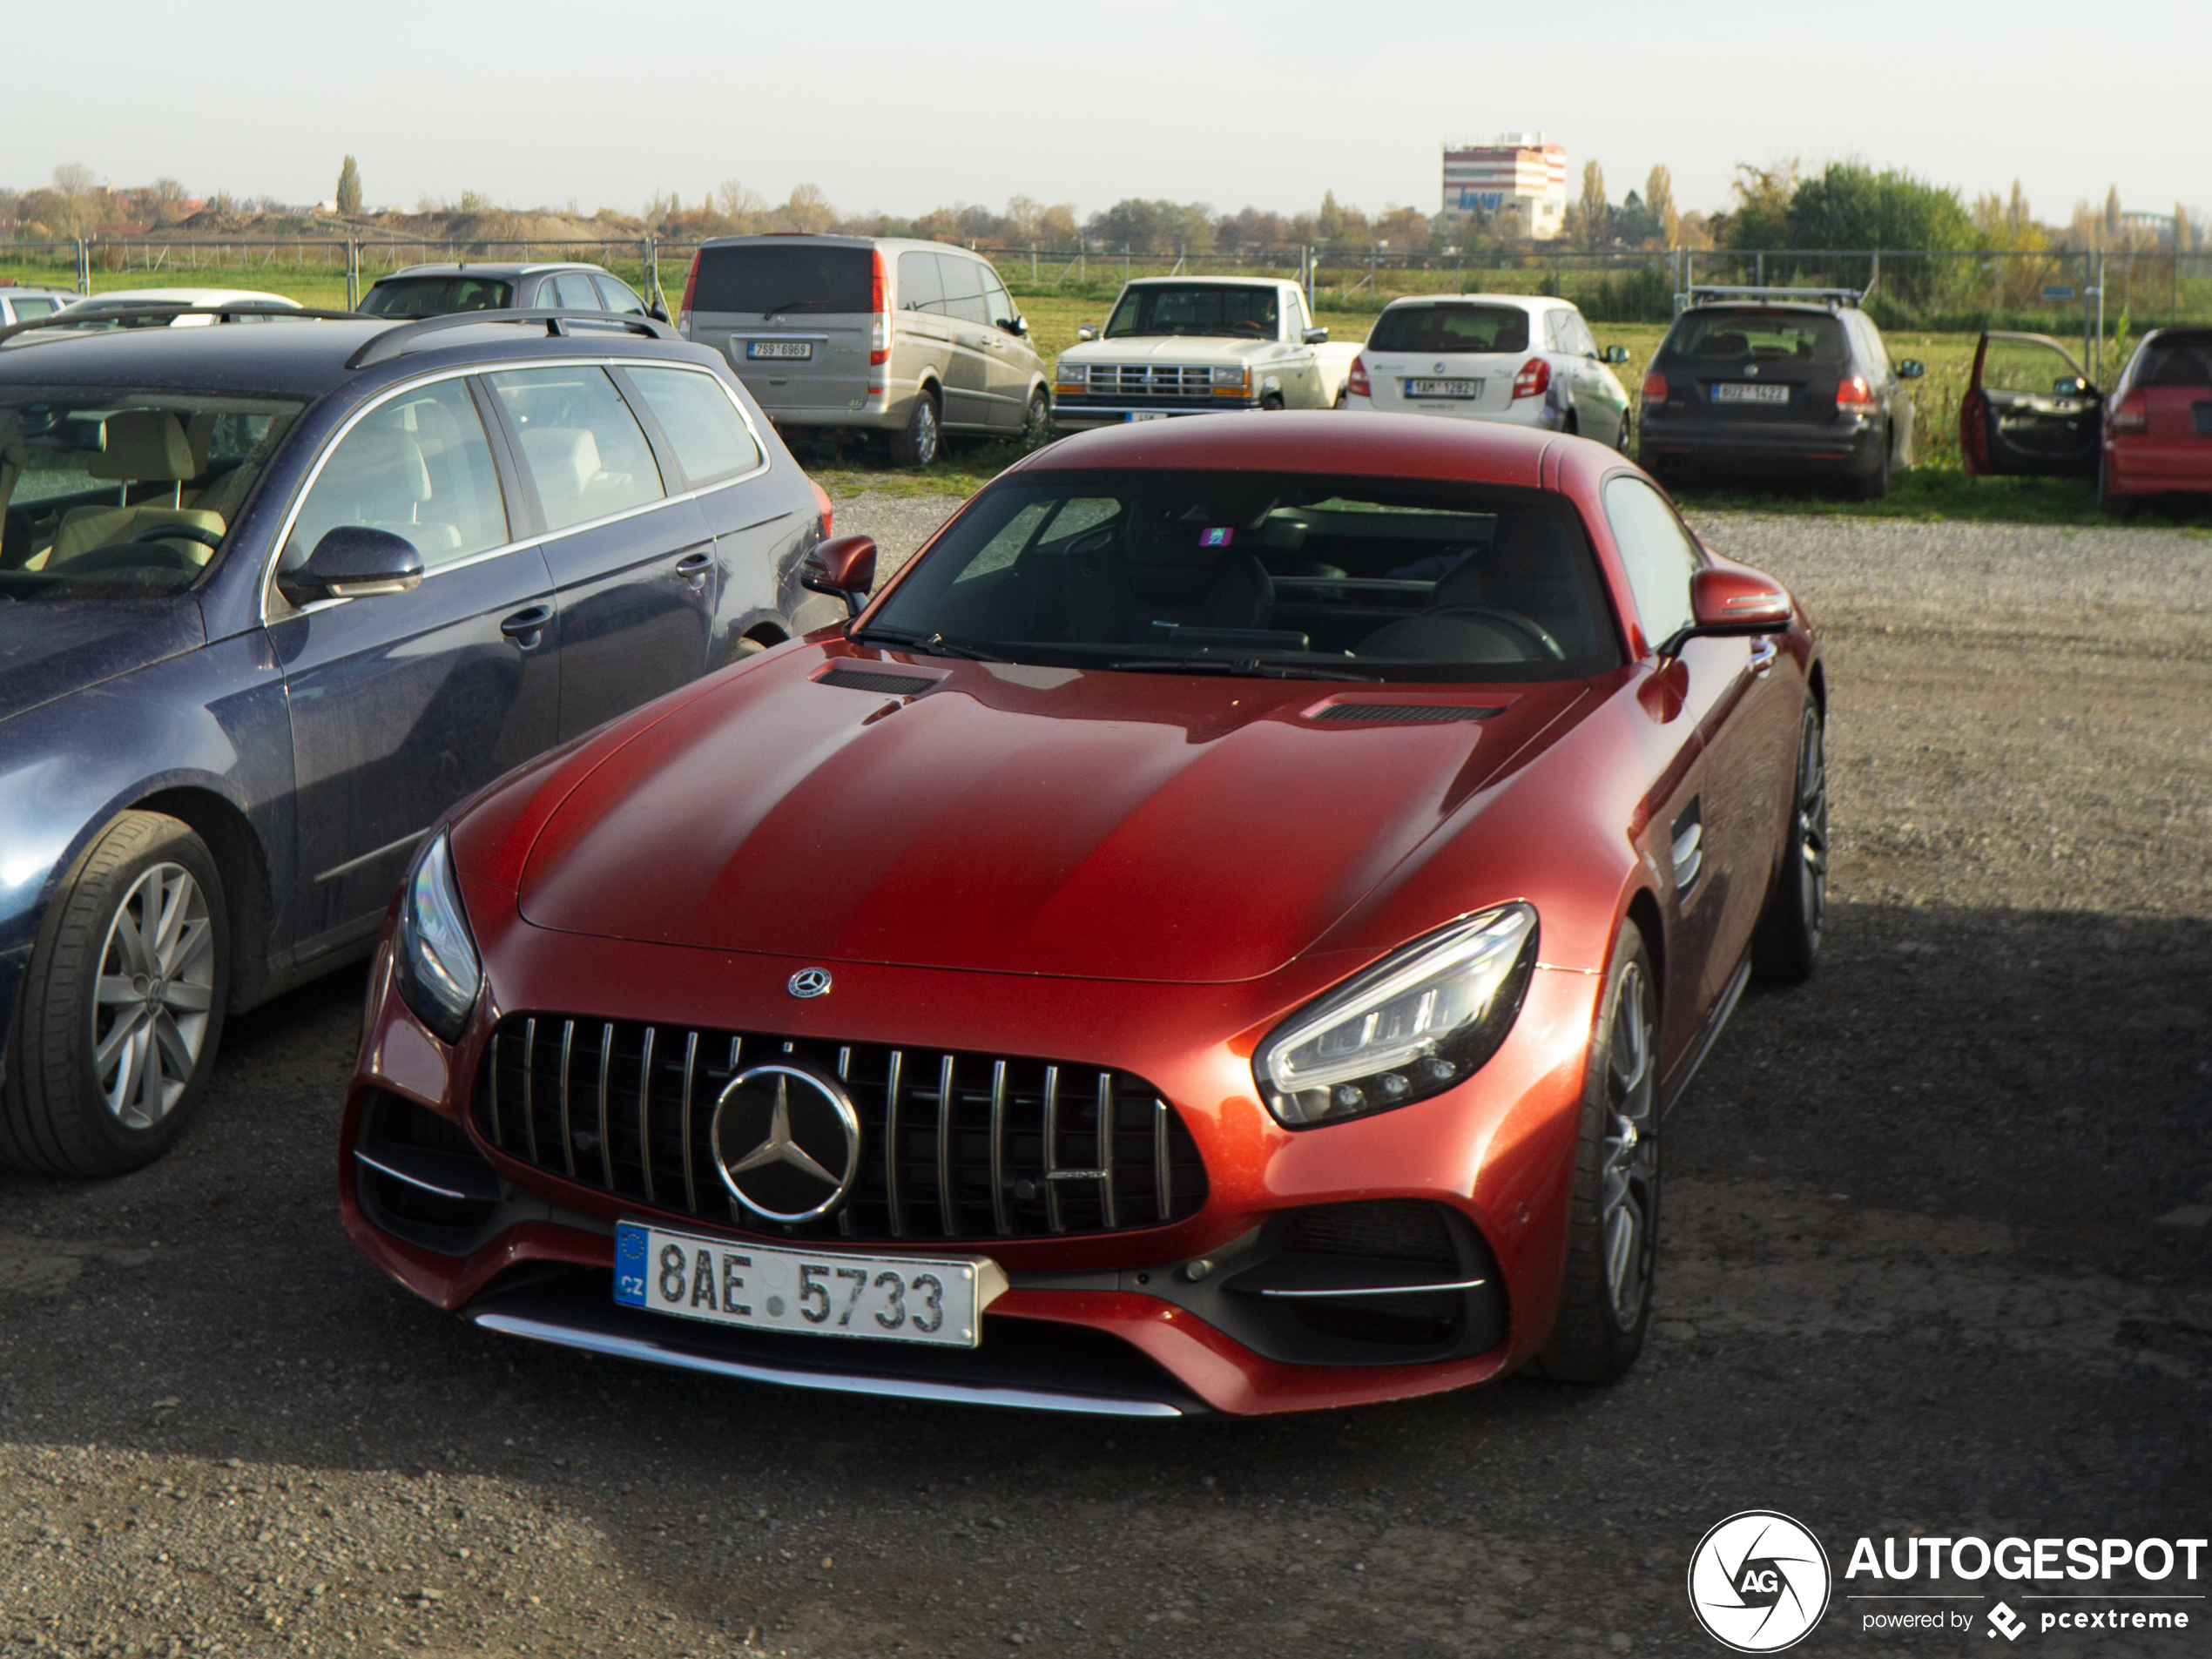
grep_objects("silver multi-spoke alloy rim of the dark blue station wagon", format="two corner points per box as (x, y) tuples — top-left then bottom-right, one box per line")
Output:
(91, 863), (214, 1128)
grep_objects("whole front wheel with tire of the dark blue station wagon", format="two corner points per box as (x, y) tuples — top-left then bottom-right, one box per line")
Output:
(0, 812), (230, 1177)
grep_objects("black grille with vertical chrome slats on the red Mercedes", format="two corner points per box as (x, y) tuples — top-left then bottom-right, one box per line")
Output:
(475, 1013), (1205, 1238)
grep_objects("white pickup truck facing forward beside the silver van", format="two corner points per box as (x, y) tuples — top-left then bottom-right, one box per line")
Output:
(1053, 277), (1360, 431)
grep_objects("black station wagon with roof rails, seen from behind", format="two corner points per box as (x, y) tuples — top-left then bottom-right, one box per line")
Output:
(1637, 287), (1926, 500)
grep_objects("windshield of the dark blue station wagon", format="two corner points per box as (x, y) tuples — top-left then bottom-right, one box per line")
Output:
(0, 388), (299, 602)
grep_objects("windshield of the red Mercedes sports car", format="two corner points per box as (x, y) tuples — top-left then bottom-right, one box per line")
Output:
(859, 471), (1619, 681)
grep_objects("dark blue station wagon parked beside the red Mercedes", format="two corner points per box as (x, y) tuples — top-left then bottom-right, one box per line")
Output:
(0, 312), (839, 1175)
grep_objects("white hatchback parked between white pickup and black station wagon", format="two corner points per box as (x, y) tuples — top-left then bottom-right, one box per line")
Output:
(1345, 294), (1630, 444)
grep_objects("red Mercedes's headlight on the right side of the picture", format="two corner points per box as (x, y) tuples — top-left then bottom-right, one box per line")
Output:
(1252, 905), (1537, 1128)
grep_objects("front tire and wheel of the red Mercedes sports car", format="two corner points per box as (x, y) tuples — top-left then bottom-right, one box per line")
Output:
(1533, 922), (1659, 1383)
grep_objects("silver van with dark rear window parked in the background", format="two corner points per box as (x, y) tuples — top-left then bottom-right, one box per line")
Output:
(677, 234), (1051, 467)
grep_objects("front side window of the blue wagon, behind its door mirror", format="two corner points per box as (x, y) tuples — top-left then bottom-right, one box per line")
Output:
(285, 381), (509, 570)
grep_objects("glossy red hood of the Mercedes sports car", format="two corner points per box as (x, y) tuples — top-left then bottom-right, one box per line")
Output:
(513, 646), (1584, 982)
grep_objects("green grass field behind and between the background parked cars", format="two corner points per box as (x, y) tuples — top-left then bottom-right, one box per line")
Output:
(0, 259), (2212, 533)
